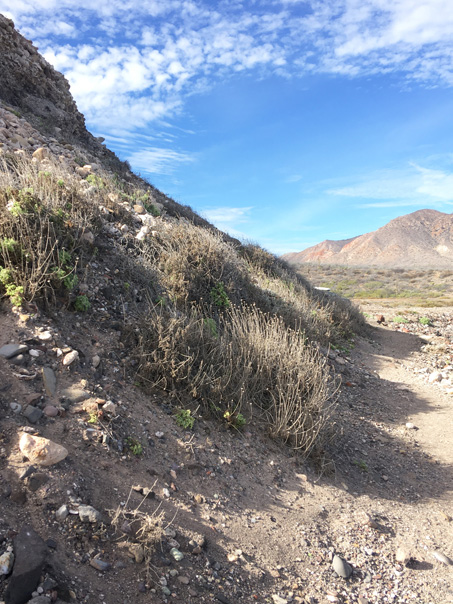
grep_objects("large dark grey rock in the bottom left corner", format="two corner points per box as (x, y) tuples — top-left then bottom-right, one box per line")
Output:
(5, 526), (48, 604)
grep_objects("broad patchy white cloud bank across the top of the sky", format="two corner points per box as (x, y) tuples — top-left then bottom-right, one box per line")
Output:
(0, 0), (453, 139)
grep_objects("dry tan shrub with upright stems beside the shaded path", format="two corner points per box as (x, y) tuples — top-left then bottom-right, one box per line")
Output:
(131, 305), (335, 453)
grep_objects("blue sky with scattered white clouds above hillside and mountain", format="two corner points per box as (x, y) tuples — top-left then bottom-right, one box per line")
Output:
(0, 0), (453, 254)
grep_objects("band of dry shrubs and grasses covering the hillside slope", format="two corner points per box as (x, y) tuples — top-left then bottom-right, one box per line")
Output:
(0, 155), (365, 453)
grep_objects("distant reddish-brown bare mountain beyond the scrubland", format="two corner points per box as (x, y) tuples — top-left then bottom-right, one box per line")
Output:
(283, 210), (453, 268)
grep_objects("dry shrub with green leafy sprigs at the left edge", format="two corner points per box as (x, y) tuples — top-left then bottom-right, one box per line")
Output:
(0, 159), (100, 301)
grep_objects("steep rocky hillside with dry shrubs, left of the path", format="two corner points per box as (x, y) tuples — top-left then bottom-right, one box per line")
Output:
(0, 16), (380, 604)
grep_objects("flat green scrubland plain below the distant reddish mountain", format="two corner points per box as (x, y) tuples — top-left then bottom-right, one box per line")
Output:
(298, 264), (453, 307)
